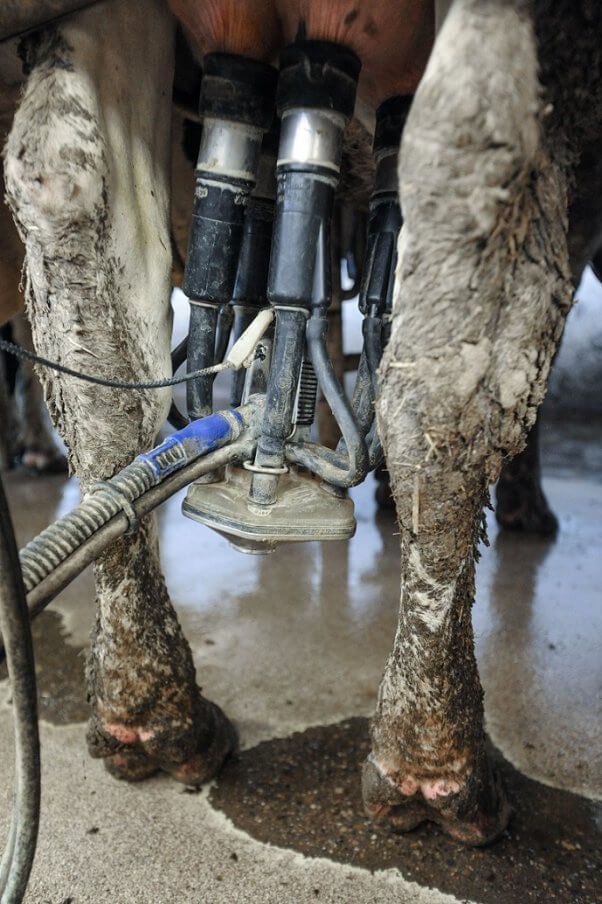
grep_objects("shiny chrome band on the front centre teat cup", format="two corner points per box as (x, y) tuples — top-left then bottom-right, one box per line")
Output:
(278, 109), (345, 173)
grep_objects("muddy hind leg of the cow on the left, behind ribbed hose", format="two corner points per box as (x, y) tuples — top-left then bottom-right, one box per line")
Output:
(6, 0), (234, 782)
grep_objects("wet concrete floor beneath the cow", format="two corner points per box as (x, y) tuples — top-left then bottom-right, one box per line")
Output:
(0, 412), (602, 904)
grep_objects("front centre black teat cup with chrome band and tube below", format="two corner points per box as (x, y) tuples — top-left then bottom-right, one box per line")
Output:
(250, 41), (360, 505)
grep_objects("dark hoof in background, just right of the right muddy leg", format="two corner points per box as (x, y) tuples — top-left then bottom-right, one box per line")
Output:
(495, 476), (558, 537)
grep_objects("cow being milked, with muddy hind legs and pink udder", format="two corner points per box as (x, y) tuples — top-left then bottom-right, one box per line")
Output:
(5, 0), (602, 844)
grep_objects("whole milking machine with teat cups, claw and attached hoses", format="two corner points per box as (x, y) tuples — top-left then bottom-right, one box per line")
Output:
(0, 33), (409, 904)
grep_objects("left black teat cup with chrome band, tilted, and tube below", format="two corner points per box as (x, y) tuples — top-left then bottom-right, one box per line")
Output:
(183, 53), (277, 419)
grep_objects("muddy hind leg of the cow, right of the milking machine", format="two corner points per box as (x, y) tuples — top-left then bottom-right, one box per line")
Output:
(364, 0), (571, 844)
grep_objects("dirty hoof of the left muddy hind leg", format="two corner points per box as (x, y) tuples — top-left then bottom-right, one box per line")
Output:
(87, 698), (238, 785)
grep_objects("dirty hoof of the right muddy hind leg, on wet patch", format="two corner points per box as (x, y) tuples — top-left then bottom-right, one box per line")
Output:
(362, 756), (512, 847)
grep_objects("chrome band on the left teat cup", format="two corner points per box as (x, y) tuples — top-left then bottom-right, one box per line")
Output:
(196, 116), (263, 182)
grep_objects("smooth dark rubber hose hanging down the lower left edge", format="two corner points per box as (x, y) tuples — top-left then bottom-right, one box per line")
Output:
(0, 470), (40, 904)
